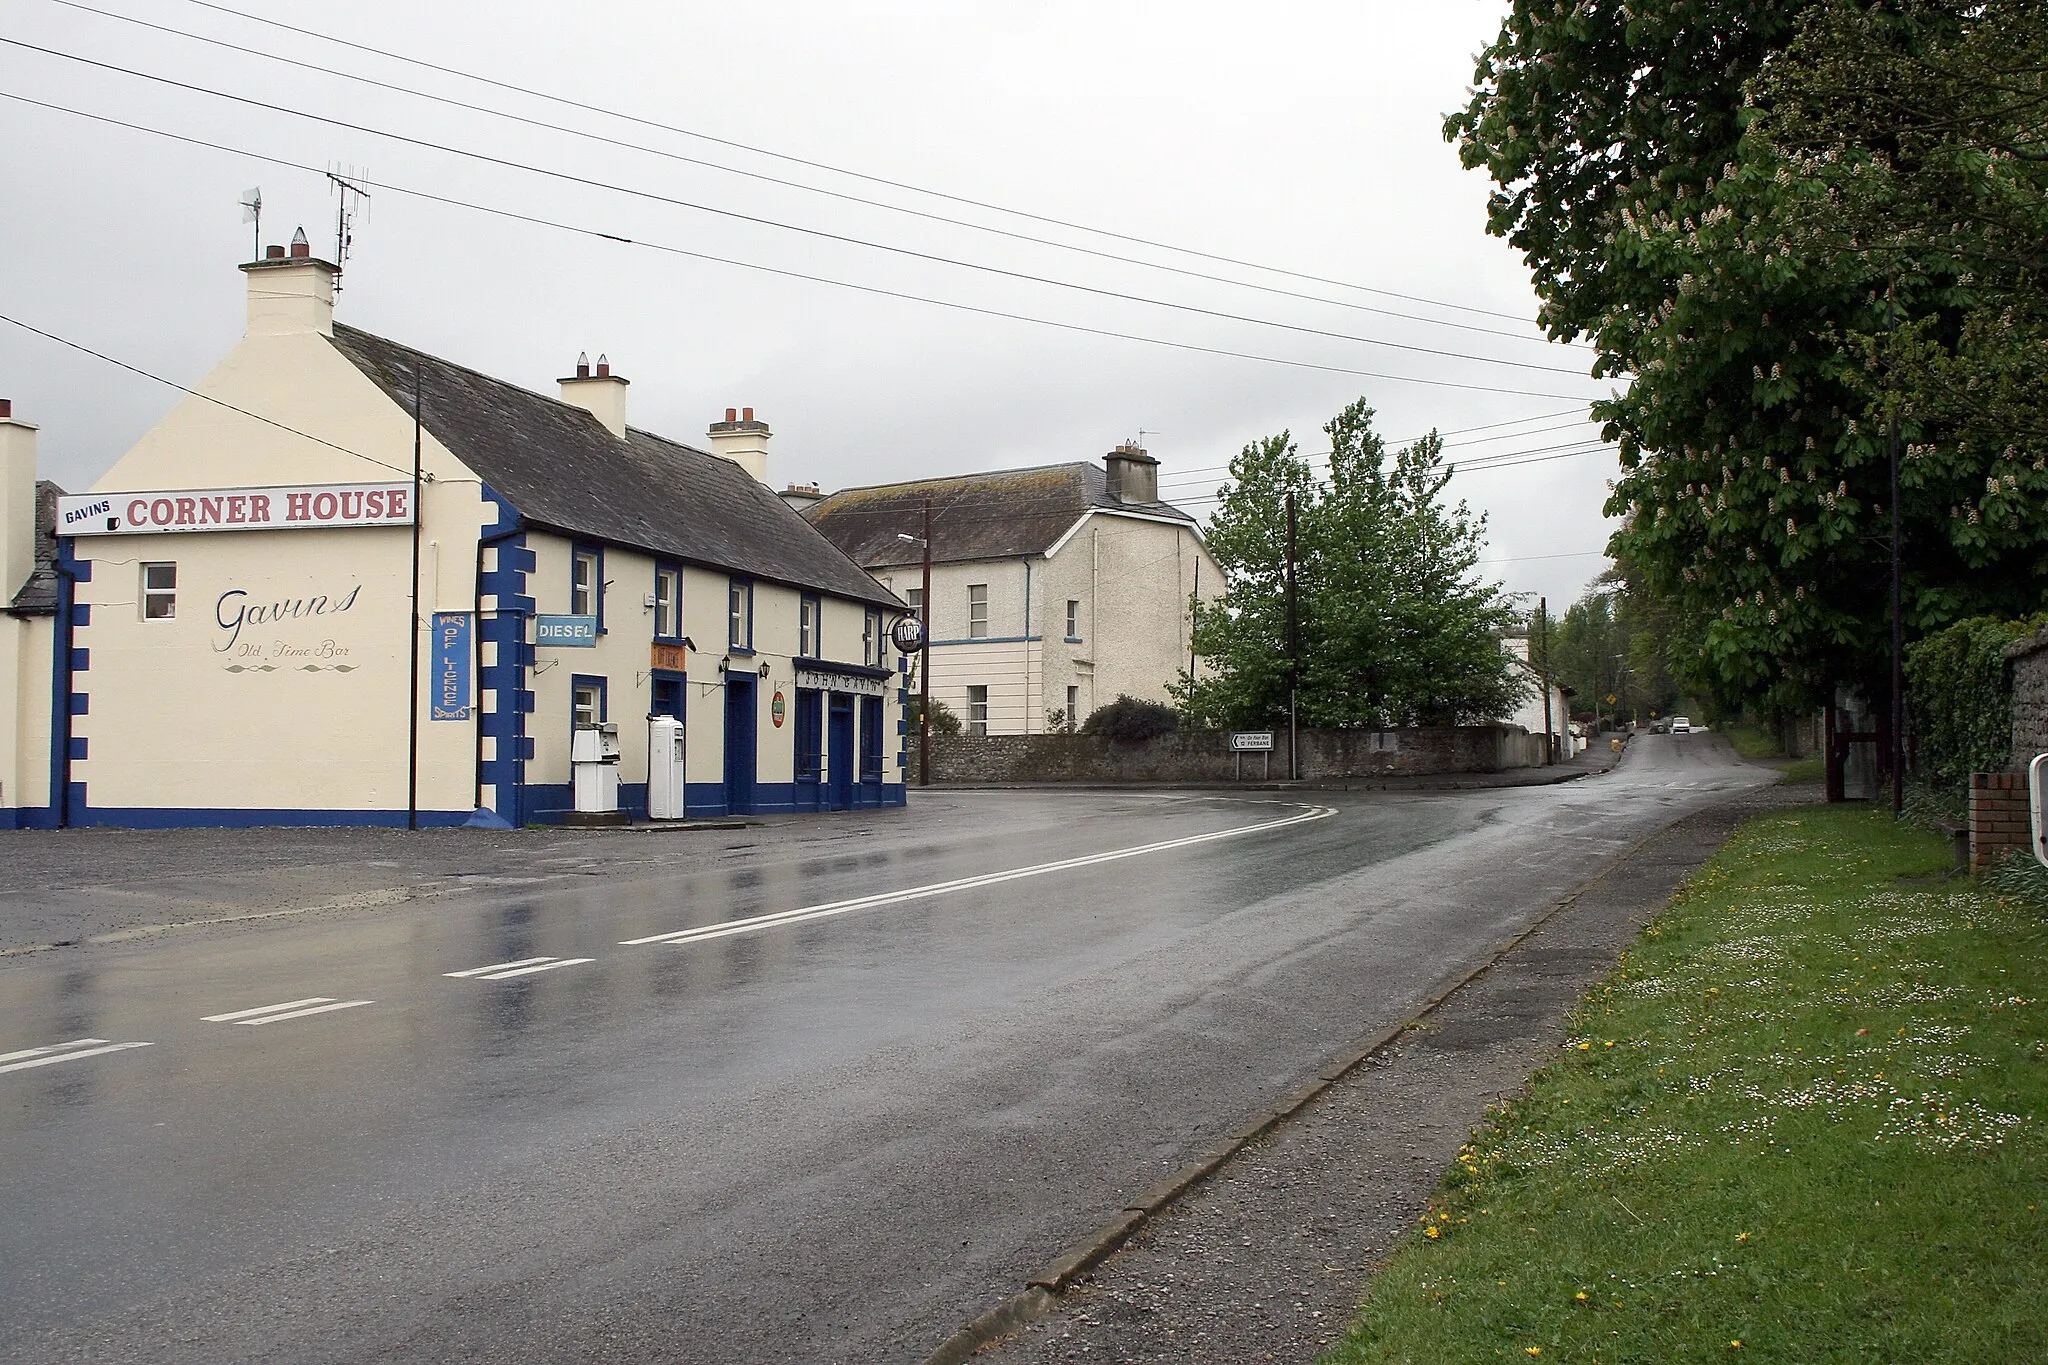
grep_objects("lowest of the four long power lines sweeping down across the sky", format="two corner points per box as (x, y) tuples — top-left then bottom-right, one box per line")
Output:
(0, 87), (1585, 401)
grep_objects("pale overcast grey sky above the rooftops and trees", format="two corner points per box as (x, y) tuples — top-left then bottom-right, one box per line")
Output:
(0, 0), (1614, 610)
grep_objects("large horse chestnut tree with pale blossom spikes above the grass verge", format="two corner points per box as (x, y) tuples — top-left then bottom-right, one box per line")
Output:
(1446, 0), (2048, 712)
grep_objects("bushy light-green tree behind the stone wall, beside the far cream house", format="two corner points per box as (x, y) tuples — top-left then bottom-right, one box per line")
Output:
(1178, 399), (1520, 726)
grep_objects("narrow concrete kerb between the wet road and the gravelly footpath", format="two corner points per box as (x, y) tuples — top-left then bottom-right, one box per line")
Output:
(924, 794), (1677, 1365)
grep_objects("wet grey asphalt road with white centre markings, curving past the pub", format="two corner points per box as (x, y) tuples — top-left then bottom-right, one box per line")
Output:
(0, 737), (1776, 1361)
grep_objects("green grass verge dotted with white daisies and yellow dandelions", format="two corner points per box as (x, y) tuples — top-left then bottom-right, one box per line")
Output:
(1325, 806), (2048, 1365)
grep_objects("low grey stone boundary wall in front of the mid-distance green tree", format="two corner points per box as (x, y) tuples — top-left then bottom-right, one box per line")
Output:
(932, 724), (1542, 786)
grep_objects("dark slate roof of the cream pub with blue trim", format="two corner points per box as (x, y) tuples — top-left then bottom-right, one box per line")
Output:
(332, 323), (901, 606)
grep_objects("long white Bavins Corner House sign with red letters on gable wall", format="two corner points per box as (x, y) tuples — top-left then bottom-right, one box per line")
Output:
(57, 479), (414, 536)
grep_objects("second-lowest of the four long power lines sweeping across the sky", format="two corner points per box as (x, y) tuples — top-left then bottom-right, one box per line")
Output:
(0, 37), (1587, 377)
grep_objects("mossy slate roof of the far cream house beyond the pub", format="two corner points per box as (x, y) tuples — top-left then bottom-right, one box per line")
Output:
(803, 460), (1194, 569)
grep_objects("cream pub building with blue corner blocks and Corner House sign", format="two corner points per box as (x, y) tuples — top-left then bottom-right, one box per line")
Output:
(16, 244), (905, 827)
